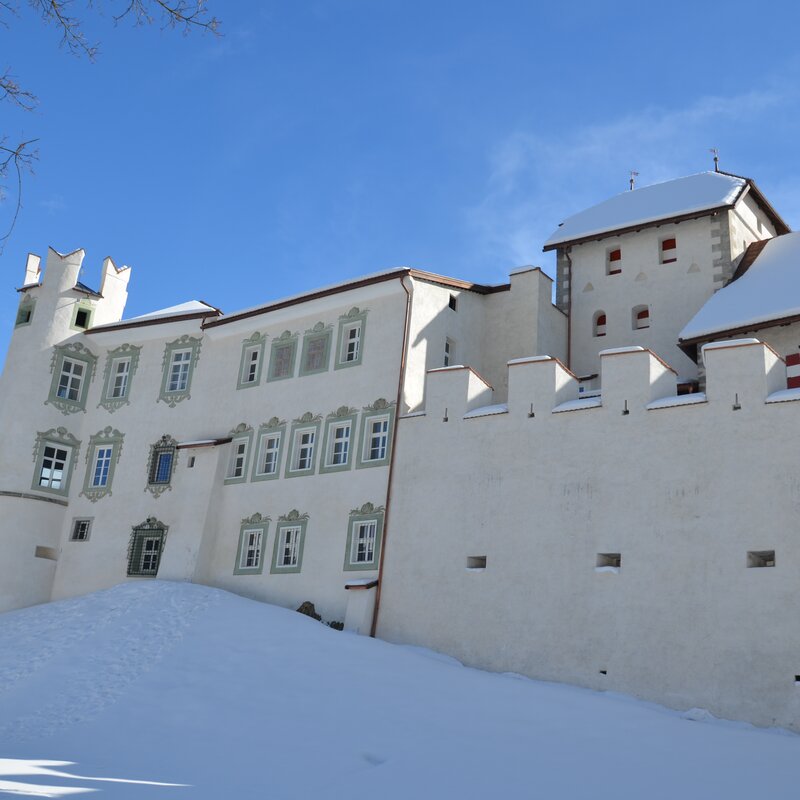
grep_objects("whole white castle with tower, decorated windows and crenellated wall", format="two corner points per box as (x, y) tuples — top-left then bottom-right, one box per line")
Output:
(0, 172), (800, 730)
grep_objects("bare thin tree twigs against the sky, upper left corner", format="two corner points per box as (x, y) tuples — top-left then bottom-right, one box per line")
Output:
(0, 0), (220, 255)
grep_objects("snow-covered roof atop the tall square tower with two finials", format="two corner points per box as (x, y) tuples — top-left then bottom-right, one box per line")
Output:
(544, 172), (747, 250)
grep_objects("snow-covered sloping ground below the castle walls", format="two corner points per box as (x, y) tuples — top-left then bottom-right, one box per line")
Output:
(0, 582), (800, 800)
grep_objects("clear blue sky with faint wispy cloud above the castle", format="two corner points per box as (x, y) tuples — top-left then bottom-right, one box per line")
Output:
(0, 0), (800, 350)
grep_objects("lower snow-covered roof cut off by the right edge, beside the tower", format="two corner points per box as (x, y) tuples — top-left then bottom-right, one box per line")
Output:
(680, 233), (800, 341)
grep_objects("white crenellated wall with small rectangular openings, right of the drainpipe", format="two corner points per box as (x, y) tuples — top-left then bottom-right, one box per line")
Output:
(377, 340), (800, 730)
